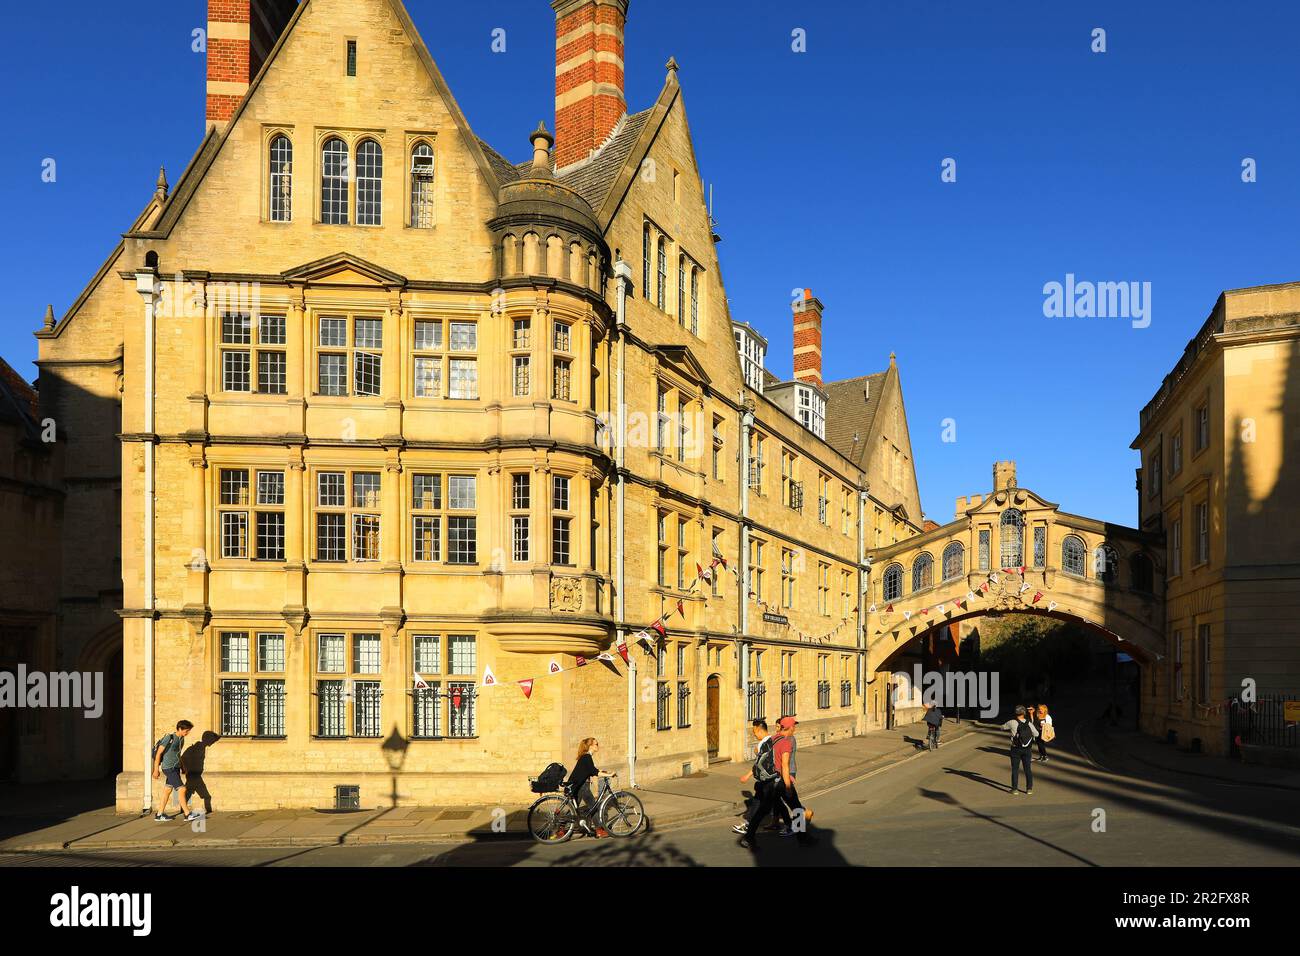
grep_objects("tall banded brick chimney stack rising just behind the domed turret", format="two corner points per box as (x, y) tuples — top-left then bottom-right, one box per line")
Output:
(551, 0), (628, 169)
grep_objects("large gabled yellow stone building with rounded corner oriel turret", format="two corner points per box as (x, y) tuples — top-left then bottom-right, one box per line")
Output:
(38, 0), (922, 810)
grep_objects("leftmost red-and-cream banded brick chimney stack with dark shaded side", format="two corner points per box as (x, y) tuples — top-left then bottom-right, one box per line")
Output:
(207, 0), (298, 127)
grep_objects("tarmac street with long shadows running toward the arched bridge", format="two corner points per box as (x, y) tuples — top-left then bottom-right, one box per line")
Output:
(0, 708), (1300, 868)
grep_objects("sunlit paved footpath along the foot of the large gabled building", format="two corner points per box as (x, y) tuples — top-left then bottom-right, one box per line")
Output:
(0, 719), (974, 853)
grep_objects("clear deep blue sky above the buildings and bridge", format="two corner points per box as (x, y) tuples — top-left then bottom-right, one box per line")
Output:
(0, 0), (1300, 524)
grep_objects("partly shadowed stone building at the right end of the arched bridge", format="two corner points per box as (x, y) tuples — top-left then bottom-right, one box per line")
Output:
(1132, 282), (1300, 753)
